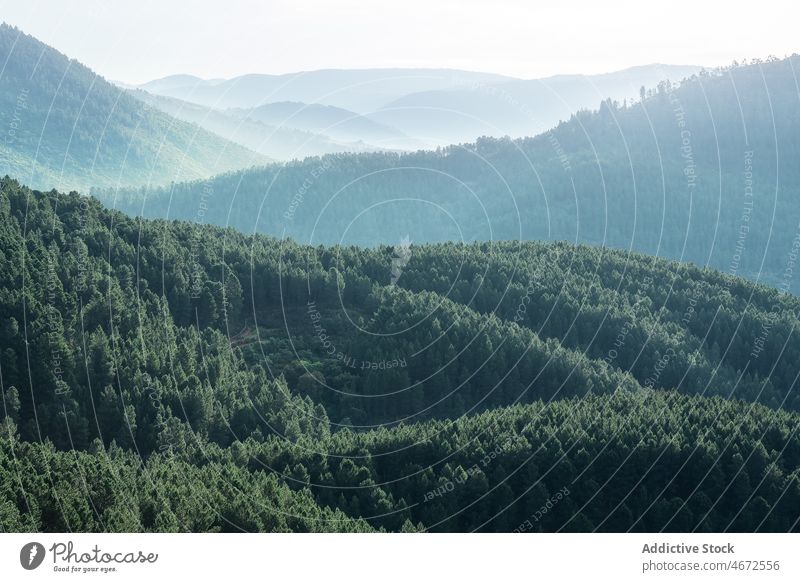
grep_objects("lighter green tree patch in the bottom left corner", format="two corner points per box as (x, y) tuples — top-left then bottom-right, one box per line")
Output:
(0, 438), (374, 532)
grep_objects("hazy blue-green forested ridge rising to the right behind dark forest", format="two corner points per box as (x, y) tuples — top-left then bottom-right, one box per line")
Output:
(103, 56), (800, 290)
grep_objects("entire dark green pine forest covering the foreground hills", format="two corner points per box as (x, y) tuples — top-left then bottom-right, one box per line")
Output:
(0, 179), (800, 531)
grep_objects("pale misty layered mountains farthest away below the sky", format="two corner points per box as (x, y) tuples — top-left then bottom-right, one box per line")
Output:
(137, 64), (701, 154)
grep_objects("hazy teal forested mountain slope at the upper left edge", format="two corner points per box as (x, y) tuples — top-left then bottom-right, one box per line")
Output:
(0, 24), (267, 190)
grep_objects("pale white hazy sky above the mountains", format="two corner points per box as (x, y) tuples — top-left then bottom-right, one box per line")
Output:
(0, 0), (800, 83)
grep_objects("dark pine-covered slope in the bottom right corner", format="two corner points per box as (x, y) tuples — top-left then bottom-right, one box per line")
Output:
(252, 392), (800, 532)
